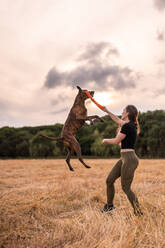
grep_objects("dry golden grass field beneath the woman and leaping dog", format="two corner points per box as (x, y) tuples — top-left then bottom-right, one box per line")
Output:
(0, 159), (165, 248)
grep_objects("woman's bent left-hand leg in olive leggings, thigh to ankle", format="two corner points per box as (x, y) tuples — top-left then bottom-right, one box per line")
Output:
(106, 159), (122, 206)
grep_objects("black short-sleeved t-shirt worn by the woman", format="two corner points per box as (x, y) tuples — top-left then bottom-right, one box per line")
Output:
(120, 121), (137, 149)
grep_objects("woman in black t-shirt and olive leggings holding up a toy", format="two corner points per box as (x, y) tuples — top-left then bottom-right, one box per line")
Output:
(102, 105), (143, 216)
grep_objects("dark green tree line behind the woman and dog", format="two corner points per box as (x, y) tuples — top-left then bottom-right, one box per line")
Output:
(0, 110), (165, 158)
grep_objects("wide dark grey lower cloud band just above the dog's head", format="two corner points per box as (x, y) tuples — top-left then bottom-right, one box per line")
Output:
(45, 64), (135, 90)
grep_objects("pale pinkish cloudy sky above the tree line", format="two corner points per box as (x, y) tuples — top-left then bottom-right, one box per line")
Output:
(0, 0), (165, 127)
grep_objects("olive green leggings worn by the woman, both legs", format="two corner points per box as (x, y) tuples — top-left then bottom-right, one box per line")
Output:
(106, 151), (140, 212)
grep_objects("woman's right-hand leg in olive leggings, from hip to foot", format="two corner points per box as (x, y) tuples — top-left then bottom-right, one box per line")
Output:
(121, 152), (142, 215)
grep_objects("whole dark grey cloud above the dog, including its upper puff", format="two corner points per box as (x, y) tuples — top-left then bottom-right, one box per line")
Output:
(44, 42), (138, 91)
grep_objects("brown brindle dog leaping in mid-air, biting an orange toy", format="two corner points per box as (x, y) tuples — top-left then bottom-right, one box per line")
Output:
(40, 86), (104, 171)
